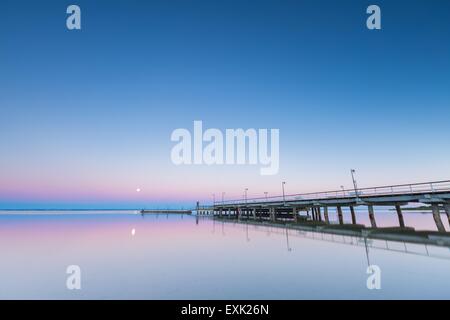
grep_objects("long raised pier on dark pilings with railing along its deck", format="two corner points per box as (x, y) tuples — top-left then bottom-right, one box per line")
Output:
(195, 180), (450, 233)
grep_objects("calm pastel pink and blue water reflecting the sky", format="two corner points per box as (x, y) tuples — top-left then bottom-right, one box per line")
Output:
(0, 211), (450, 299)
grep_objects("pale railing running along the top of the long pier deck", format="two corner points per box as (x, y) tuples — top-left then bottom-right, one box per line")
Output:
(215, 180), (450, 206)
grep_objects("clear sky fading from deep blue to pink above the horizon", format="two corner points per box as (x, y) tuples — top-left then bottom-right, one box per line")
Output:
(0, 0), (450, 208)
